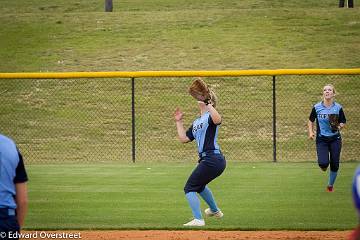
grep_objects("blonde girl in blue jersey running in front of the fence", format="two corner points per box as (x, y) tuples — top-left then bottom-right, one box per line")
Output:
(308, 84), (346, 192)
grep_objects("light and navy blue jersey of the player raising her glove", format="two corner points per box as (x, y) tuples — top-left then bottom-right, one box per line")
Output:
(186, 112), (220, 153)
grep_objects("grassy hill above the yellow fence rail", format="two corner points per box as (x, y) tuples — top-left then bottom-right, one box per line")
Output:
(0, 0), (360, 72)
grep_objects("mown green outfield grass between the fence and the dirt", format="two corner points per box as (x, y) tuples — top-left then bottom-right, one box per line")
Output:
(25, 162), (357, 230)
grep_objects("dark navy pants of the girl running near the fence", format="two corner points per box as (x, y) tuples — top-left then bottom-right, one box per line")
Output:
(316, 136), (342, 172)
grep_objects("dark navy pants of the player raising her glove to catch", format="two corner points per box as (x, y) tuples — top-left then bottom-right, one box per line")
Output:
(184, 154), (226, 194)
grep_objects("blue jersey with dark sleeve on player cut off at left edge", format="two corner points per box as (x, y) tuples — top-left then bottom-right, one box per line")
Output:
(0, 134), (28, 209)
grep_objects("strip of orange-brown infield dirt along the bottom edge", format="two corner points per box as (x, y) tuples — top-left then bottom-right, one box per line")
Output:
(22, 230), (351, 240)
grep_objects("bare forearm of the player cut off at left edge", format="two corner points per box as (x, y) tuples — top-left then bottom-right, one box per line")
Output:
(15, 182), (28, 227)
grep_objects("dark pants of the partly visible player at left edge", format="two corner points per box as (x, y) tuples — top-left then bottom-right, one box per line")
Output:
(0, 208), (20, 240)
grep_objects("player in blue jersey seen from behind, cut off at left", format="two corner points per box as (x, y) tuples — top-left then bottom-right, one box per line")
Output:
(0, 134), (28, 239)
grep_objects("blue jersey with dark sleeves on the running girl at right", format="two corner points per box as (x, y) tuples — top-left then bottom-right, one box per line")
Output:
(309, 101), (346, 137)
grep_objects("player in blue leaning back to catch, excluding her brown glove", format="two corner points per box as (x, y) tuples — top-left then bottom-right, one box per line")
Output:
(174, 83), (226, 227)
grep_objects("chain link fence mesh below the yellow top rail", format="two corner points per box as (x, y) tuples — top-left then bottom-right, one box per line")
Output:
(0, 75), (360, 164)
